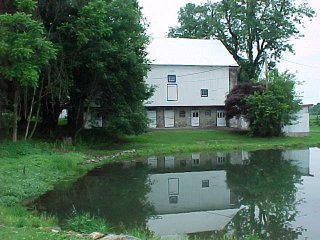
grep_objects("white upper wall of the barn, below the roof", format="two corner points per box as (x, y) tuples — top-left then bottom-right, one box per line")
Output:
(145, 65), (229, 107)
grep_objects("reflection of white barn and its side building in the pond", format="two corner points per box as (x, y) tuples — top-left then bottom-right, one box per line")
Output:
(137, 149), (309, 235)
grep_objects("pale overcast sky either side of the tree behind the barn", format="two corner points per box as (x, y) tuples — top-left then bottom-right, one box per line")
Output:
(138, 0), (320, 104)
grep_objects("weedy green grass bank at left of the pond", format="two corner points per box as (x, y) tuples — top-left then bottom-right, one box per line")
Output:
(0, 142), (89, 239)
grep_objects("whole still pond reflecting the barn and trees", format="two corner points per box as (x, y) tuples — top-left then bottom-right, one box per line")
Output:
(33, 148), (320, 239)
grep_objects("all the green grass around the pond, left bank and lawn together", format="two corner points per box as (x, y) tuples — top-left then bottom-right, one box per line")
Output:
(0, 126), (320, 239)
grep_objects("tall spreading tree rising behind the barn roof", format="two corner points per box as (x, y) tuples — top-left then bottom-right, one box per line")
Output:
(169, 0), (314, 81)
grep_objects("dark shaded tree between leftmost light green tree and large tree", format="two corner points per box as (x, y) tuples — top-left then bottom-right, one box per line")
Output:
(37, 0), (80, 133)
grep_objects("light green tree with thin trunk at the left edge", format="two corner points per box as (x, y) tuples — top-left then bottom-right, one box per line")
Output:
(0, 0), (55, 141)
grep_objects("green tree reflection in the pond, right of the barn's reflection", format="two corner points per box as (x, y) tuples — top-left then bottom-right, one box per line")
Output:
(227, 150), (303, 240)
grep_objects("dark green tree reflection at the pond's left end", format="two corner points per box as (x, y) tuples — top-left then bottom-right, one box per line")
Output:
(36, 164), (154, 229)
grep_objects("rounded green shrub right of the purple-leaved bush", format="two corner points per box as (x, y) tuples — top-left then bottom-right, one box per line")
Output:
(245, 72), (301, 137)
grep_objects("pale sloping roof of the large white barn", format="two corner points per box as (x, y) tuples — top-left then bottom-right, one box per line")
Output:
(148, 38), (237, 66)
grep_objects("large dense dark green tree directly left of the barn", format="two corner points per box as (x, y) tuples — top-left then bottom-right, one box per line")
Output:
(65, 0), (150, 139)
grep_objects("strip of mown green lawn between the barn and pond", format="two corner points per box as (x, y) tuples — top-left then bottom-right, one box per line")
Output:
(79, 126), (320, 156)
